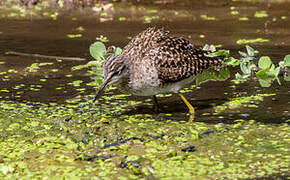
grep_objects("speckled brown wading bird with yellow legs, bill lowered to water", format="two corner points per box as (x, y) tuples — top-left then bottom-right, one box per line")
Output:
(94, 28), (224, 120)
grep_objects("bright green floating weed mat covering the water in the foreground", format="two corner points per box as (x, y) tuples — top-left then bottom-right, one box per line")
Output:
(0, 99), (289, 179)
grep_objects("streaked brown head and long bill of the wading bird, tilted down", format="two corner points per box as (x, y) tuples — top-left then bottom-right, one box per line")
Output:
(93, 55), (128, 101)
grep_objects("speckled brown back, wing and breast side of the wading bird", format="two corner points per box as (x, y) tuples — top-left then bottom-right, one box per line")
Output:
(122, 28), (224, 93)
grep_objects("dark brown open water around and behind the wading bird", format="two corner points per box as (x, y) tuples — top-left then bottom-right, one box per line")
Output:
(0, 0), (290, 123)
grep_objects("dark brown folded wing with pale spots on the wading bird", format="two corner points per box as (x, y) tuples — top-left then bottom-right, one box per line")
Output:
(148, 36), (224, 83)
